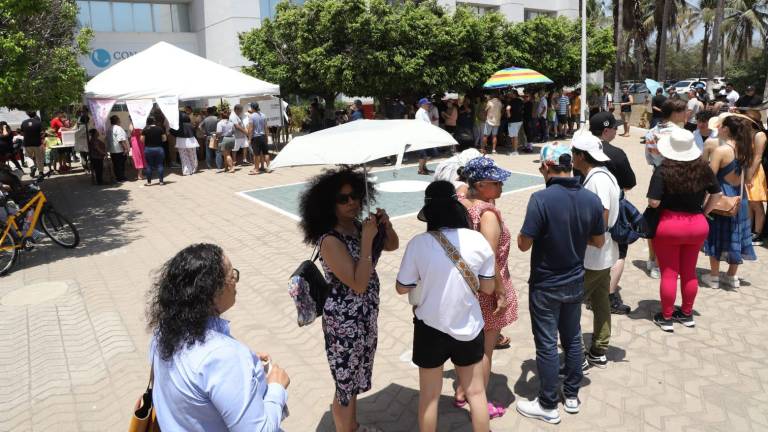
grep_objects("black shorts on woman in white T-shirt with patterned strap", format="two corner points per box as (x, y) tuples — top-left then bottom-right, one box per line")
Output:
(413, 317), (484, 369)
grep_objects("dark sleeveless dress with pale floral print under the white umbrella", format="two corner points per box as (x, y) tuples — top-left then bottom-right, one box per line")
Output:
(320, 227), (381, 406)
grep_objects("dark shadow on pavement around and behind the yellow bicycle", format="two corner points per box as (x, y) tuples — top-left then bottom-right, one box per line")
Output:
(9, 174), (141, 270)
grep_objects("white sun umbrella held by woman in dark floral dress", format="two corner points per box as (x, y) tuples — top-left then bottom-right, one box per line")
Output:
(269, 120), (458, 204)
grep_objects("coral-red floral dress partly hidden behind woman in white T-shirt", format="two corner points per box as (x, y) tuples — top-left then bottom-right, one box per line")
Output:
(468, 201), (517, 330)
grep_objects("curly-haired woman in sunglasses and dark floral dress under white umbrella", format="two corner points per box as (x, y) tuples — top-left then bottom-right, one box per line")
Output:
(300, 168), (399, 432)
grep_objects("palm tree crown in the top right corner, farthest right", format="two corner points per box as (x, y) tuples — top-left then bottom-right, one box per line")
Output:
(723, 0), (768, 61)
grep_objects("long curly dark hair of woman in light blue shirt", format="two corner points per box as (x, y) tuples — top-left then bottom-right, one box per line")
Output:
(147, 243), (226, 360)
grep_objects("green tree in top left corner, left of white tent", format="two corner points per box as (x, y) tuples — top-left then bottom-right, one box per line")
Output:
(0, 0), (93, 109)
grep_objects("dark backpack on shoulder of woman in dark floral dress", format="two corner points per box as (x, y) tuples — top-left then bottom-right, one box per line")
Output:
(288, 248), (329, 327)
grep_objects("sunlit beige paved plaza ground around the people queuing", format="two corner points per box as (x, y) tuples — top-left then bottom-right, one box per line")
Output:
(0, 129), (768, 432)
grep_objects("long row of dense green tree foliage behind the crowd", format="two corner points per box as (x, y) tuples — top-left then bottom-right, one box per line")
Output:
(240, 0), (615, 97)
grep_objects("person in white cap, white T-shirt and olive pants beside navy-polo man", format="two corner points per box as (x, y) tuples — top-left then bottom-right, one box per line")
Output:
(572, 133), (621, 368)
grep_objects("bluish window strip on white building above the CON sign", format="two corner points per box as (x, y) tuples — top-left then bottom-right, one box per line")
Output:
(77, 0), (190, 33)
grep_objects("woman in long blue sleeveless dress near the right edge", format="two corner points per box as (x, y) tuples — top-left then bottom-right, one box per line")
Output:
(701, 113), (757, 289)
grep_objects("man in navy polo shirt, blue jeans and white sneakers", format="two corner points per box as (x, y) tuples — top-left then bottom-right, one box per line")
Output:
(517, 144), (605, 424)
